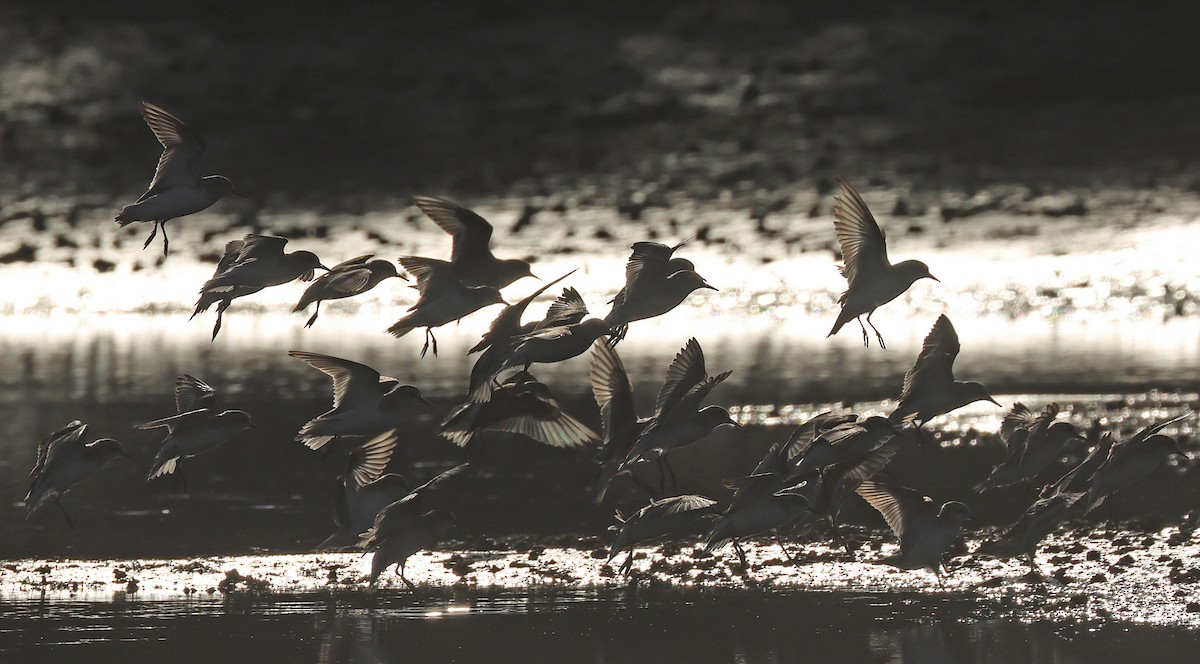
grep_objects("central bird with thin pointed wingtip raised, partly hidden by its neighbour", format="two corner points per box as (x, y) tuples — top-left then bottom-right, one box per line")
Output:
(467, 270), (578, 401)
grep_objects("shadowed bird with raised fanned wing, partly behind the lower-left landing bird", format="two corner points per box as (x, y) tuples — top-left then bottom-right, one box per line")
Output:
(317, 429), (412, 550)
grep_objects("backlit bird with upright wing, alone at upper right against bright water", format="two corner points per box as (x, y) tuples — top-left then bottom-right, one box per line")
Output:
(826, 178), (940, 348)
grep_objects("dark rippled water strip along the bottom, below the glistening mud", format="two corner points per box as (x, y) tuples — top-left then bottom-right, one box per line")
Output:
(0, 590), (1200, 664)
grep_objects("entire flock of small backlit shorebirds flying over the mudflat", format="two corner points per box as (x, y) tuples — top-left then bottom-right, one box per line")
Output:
(16, 103), (1190, 587)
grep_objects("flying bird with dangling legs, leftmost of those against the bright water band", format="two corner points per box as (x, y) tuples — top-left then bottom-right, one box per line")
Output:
(188, 233), (329, 340)
